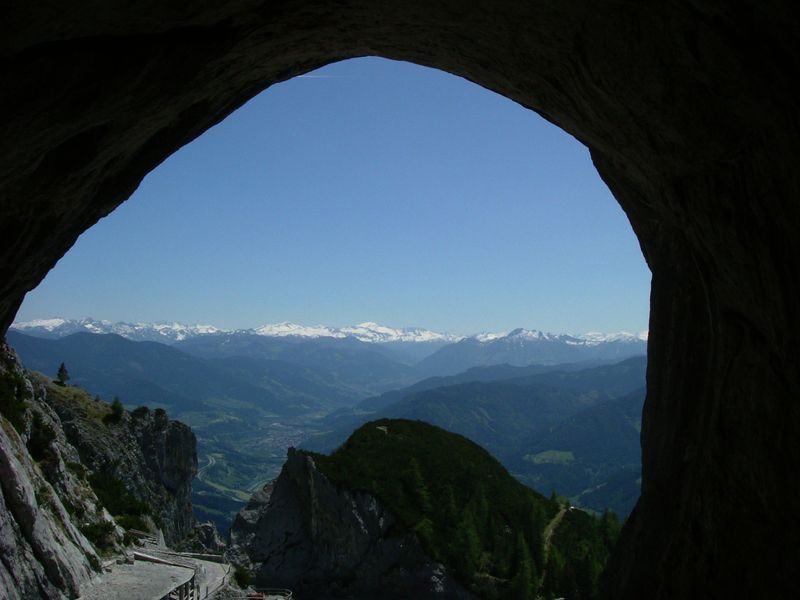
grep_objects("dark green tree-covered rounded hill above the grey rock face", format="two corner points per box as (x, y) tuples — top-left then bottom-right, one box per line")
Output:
(308, 419), (618, 600)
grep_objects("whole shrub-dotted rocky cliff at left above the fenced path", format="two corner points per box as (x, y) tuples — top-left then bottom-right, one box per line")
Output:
(0, 345), (197, 600)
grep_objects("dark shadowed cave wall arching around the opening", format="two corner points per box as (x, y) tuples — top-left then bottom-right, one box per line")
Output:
(0, 0), (800, 599)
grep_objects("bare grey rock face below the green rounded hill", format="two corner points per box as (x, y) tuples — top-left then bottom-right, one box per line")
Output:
(229, 449), (473, 600)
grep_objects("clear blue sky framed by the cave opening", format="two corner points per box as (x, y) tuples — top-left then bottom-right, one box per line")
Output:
(17, 58), (650, 334)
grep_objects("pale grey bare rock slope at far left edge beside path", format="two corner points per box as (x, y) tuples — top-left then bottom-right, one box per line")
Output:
(0, 346), (99, 600)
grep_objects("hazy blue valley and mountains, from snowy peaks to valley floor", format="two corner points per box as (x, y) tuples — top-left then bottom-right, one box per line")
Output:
(8, 318), (646, 531)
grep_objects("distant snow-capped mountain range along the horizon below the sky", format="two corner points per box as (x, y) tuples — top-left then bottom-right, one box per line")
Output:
(11, 318), (647, 368)
